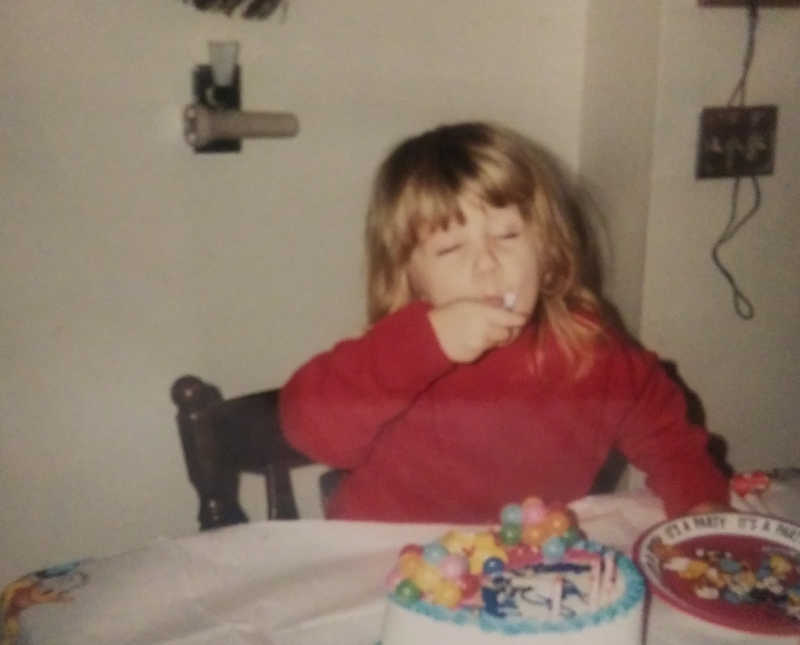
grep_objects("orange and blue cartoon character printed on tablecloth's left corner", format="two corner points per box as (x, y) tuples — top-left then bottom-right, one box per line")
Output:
(0, 562), (89, 645)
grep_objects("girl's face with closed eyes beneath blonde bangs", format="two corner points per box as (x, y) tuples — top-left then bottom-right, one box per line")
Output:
(407, 194), (539, 314)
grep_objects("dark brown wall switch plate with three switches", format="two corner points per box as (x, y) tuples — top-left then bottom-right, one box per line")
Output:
(695, 105), (778, 179)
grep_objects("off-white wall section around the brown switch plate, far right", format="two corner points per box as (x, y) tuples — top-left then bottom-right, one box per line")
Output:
(641, 0), (800, 469)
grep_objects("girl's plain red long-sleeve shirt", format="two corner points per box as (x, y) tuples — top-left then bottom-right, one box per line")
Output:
(280, 302), (728, 523)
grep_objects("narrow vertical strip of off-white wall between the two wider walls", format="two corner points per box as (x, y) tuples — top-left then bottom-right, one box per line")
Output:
(580, 0), (660, 333)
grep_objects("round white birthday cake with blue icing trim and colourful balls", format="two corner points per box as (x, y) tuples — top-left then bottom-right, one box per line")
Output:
(381, 498), (645, 645)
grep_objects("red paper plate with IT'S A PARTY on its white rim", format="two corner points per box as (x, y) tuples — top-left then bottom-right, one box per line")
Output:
(633, 513), (800, 635)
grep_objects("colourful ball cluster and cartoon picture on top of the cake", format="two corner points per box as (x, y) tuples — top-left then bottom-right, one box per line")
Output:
(387, 497), (619, 620)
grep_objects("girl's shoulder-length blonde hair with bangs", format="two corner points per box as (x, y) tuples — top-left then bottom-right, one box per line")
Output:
(366, 123), (603, 371)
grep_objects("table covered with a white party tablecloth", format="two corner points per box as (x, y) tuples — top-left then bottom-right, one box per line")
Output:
(2, 480), (800, 645)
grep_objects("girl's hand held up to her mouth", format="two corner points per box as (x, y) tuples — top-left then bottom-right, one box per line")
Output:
(428, 300), (528, 363)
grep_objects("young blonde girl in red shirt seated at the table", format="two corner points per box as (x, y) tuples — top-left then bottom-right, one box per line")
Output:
(280, 123), (728, 523)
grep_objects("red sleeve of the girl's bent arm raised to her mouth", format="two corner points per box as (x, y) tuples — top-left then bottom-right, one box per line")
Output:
(280, 302), (453, 468)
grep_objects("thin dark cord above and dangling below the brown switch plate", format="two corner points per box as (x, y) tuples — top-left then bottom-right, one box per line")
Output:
(711, 0), (761, 320)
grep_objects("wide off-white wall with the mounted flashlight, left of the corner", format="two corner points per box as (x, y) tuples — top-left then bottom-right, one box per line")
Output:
(0, 0), (587, 579)
